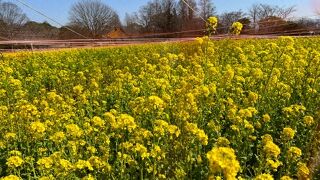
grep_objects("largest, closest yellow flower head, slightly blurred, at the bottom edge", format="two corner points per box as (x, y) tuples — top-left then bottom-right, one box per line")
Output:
(207, 147), (240, 179)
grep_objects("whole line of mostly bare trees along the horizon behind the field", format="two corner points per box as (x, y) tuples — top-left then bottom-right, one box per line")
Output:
(0, 0), (319, 40)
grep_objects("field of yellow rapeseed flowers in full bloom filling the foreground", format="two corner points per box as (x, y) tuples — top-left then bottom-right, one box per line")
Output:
(0, 36), (320, 180)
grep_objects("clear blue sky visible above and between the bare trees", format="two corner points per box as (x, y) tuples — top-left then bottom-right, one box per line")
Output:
(3, 0), (320, 26)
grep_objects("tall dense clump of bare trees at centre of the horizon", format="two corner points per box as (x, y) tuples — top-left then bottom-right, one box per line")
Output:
(124, 0), (216, 34)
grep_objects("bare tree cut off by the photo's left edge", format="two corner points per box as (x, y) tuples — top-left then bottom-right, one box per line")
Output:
(0, 2), (28, 39)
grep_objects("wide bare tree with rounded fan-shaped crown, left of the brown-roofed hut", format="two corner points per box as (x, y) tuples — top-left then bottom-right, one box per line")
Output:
(69, 0), (120, 38)
